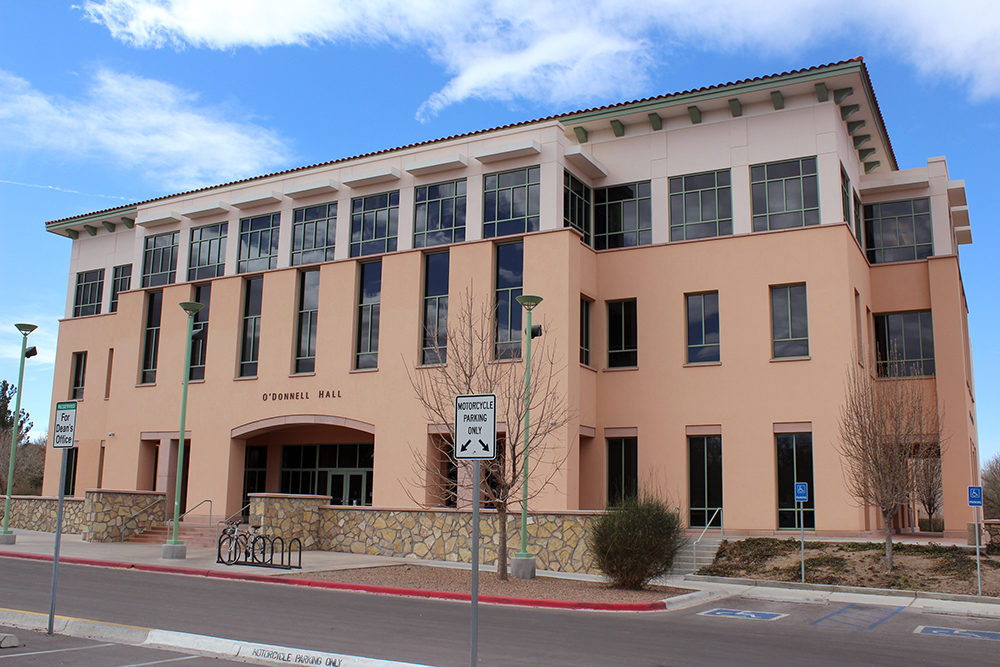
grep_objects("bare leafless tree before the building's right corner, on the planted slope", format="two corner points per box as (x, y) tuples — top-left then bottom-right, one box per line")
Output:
(838, 352), (941, 571)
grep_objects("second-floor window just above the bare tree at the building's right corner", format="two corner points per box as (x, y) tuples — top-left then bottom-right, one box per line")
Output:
(875, 310), (934, 377)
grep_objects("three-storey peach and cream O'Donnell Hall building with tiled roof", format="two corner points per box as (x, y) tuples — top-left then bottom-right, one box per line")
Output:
(44, 58), (979, 566)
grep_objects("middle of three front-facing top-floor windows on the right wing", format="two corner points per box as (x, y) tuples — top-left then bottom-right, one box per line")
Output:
(670, 169), (733, 241)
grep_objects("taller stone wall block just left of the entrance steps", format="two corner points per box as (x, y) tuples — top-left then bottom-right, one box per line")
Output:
(80, 489), (167, 542)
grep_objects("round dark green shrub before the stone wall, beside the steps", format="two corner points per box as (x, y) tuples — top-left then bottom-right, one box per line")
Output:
(587, 494), (687, 589)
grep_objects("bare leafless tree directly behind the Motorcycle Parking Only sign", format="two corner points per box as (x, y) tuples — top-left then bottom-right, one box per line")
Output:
(407, 288), (570, 581)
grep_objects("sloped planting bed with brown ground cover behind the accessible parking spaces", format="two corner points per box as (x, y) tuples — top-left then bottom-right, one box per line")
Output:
(698, 537), (1000, 597)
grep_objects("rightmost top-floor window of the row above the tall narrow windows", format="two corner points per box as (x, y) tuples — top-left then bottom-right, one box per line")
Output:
(483, 167), (541, 238)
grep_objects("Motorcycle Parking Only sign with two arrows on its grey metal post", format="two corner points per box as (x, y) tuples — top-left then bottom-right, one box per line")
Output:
(455, 394), (497, 667)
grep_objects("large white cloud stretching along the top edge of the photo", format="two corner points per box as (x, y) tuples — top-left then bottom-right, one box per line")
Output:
(83, 0), (1000, 116)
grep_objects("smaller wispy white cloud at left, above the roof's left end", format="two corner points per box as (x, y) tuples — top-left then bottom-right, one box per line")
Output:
(0, 69), (290, 189)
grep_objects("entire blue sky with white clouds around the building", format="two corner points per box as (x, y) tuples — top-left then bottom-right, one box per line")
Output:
(0, 0), (1000, 460)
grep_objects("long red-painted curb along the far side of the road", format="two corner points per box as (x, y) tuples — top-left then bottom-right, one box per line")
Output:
(0, 551), (672, 611)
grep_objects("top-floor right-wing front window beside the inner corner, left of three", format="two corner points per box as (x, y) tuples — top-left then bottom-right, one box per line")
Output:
(594, 181), (653, 250)
